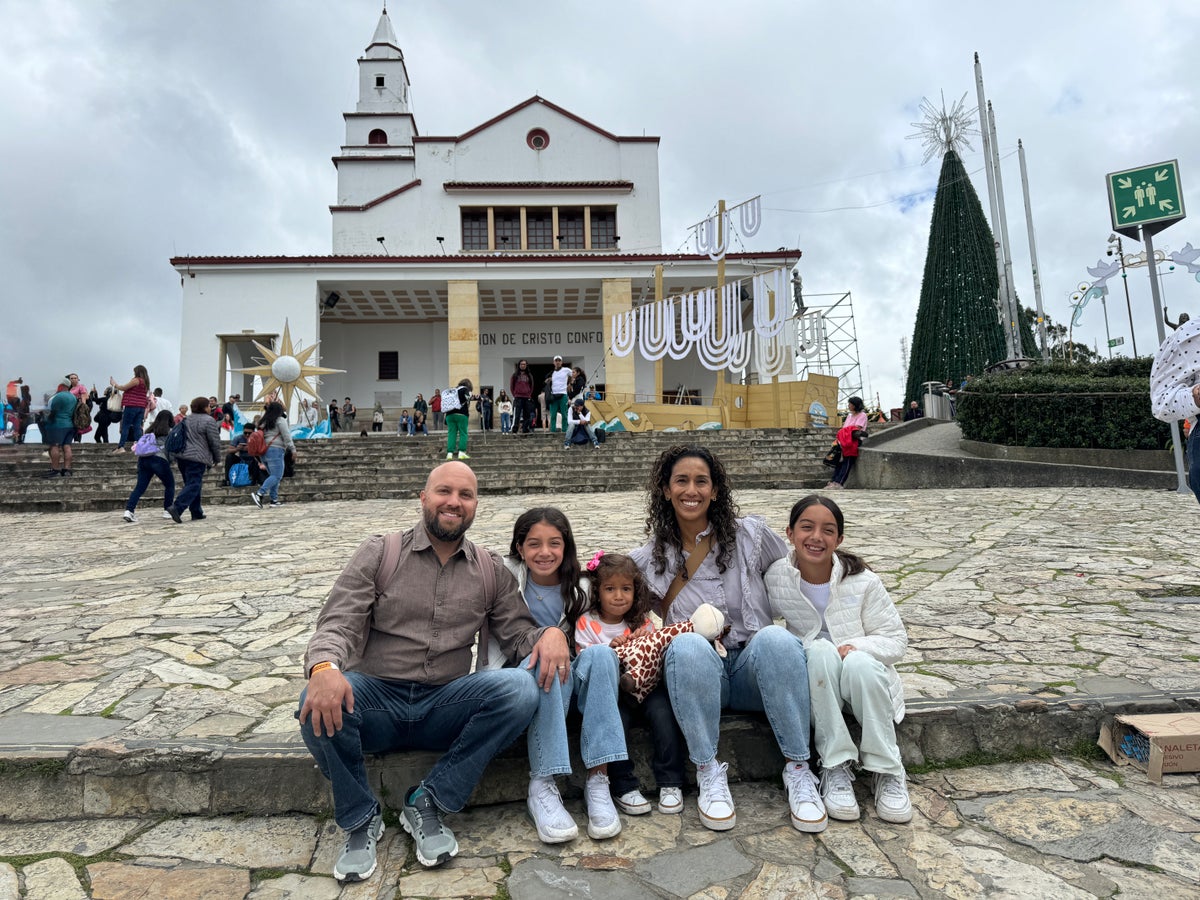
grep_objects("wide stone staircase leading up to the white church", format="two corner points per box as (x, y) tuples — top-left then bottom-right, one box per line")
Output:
(0, 428), (832, 512)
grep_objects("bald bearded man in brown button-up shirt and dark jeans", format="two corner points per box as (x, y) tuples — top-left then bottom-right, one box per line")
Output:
(299, 462), (570, 881)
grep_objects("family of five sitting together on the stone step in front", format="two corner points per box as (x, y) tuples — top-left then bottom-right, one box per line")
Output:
(299, 445), (912, 881)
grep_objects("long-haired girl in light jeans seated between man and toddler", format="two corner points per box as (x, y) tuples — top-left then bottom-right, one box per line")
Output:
(477, 506), (628, 844)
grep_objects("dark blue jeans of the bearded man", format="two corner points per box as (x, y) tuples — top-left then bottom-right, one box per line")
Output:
(300, 668), (541, 832)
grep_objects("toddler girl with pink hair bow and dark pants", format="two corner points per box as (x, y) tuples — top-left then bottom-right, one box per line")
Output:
(575, 552), (684, 816)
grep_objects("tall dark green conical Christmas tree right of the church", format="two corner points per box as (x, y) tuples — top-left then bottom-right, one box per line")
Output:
(905, 148), (1008, 403)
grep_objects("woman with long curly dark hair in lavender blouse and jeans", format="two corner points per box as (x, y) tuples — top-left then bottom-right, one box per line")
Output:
(630, 446), (827, 832)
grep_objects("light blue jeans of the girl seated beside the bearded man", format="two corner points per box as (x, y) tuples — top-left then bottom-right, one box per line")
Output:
(530, 647), (629, 778)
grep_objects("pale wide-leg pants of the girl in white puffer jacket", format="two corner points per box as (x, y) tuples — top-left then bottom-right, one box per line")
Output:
(808, 638), (904, 776)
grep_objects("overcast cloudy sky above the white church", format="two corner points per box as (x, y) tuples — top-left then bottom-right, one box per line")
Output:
(0, 0), (1200, 407)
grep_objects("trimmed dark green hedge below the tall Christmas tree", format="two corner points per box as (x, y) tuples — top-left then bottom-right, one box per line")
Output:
(958, 356), (1170, 450)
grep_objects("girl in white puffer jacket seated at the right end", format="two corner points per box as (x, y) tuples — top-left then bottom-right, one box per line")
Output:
(764, 494), (912, 823)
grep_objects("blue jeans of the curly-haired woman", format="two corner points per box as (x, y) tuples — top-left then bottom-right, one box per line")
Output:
(662, 625), (811, 766)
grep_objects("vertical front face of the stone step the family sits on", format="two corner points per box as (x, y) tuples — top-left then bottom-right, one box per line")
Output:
(0, 694), (1184, 822)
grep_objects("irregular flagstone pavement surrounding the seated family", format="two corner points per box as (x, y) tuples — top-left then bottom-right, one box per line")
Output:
(0, 489), (1200, 900)
